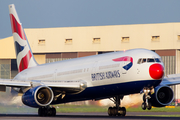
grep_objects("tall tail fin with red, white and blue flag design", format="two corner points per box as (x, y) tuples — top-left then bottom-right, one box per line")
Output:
(9, 4), (38, 72)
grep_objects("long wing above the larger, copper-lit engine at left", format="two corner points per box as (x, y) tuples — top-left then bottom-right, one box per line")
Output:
(0, 79), (87, 93)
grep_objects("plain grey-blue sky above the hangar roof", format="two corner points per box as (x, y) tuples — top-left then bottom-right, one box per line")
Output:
(0, 0), (180, 39)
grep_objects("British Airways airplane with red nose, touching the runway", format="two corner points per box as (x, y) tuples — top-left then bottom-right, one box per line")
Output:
(0, 4), (180, 116)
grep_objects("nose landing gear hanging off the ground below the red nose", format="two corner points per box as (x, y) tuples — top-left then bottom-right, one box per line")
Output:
(141, 88), (154, 110)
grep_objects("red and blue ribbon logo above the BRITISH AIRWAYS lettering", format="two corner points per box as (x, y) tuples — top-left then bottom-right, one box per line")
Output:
(113, 56), (133, 70)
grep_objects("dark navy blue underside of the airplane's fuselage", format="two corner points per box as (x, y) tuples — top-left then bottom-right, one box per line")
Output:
(52, 80), (161, 104)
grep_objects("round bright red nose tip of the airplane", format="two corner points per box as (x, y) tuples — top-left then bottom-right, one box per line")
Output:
(149, 63), (164, 79)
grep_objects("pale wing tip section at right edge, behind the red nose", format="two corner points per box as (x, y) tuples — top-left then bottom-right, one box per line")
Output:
(160, 74), (180, 86)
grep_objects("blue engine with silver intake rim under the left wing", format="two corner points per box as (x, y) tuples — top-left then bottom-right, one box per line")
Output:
(22, 86), (54, 107)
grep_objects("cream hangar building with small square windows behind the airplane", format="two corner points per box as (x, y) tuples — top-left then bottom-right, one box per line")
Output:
(0, 23), (180, 103)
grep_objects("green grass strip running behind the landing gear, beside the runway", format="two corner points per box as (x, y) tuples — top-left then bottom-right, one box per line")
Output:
(0, 104), (180, 113)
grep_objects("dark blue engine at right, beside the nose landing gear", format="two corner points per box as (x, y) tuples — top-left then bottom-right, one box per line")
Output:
(150, 86), (174, 107)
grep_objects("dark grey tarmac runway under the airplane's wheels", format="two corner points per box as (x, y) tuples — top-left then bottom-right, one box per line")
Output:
(0, 112), (180, 120)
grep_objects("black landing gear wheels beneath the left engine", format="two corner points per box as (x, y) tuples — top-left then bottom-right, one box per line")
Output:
(38, 106), (56, 116)
